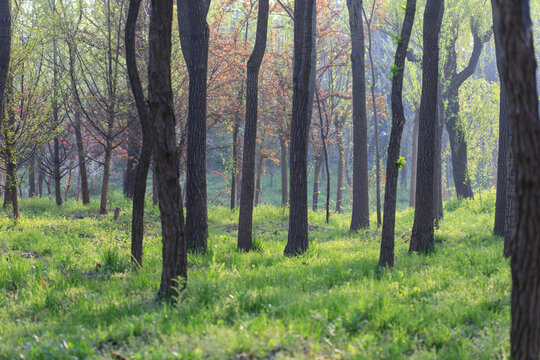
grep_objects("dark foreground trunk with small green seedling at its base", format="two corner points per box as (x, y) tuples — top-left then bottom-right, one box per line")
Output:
(148, 0), (187, 297)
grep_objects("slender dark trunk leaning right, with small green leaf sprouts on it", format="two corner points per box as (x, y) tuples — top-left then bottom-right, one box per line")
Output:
(379, 0), (416, 267)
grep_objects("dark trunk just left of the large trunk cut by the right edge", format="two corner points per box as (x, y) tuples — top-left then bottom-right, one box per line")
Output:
(491, 0), (508, 239)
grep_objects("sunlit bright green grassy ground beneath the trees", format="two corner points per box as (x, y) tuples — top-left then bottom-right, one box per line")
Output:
(0, 192), (510, 359)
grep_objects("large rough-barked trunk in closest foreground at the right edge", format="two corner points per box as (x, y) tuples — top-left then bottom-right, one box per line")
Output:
(497, 0), (540, 360)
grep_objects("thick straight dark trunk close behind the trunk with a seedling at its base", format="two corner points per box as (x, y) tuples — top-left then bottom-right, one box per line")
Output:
(178, 0), (210, 253)
